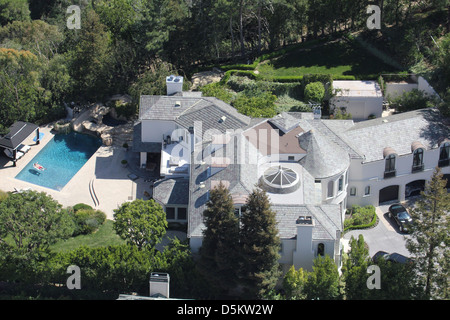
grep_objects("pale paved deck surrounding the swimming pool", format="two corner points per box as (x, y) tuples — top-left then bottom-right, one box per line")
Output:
(0, 126), (150, 220)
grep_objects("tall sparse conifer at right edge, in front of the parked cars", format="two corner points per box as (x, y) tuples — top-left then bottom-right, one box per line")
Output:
(406, 168), (450, 299)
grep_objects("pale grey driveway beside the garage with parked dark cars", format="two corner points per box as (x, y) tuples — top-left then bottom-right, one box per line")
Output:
(343, 203), (410, 257)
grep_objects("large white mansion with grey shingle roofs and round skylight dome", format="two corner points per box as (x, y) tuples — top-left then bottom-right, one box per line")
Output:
(133, 76), (450, 269)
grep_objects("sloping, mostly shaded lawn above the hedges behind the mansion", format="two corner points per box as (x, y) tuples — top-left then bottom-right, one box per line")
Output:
(257, 41), (399, 79)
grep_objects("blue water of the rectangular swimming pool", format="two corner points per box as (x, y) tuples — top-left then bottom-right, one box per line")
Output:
(16, 132), (102, 191)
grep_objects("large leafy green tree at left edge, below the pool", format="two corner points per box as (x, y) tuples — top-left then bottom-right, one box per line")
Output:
(0, 191), (74, 282)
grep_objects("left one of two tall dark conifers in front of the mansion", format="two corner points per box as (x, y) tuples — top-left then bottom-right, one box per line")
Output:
(199, 183), (239, 297)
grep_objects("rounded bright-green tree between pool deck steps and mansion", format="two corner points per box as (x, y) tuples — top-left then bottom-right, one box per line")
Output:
(114, 199), (167, 249)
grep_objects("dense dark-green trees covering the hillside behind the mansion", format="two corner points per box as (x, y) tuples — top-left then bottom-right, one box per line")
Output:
(0, 0), (450, 132)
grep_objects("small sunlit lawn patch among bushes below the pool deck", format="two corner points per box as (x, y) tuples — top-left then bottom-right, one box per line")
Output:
(51, 220), (125, 252)
